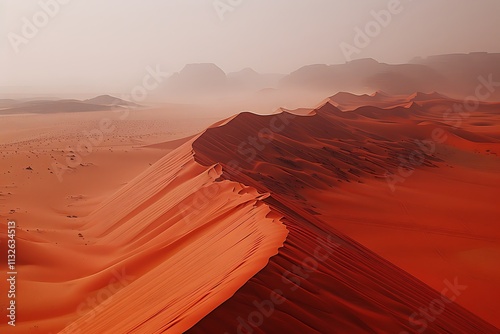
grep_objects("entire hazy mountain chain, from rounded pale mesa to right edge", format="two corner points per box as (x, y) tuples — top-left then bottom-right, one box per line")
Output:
(158, 53), (500, 104)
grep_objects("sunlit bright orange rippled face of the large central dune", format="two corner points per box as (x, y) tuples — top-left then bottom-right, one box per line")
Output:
(62, 137), (287, 333)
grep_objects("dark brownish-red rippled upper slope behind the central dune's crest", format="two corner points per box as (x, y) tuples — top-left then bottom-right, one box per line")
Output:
(193, 103), (446, 185)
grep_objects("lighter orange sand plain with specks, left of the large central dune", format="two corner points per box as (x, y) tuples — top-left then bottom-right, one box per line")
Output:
(0, 106), (219, 333)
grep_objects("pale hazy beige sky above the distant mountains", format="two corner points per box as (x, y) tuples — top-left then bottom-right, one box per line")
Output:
(0, 0), (500, 93)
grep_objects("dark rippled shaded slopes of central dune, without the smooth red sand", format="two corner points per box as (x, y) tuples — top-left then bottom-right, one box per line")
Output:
(189, 103), (499, 333)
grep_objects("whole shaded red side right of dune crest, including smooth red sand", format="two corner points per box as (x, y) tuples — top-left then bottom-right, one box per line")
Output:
(190, 94), (500, 333)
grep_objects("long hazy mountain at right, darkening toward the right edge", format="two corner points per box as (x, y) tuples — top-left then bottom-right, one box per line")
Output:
(280, 53), (500, 100)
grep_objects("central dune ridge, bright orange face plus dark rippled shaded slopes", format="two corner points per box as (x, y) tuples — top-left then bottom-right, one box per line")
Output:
(68, 98), (497, 333)
